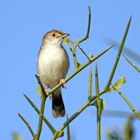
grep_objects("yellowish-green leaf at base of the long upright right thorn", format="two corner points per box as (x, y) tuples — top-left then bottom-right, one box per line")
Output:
(109, 77), (126, 92)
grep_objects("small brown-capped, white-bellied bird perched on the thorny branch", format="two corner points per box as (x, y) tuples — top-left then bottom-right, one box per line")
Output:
(37, 29), (69, 118)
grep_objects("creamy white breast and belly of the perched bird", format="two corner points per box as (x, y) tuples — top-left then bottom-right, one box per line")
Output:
(38, 46), (69, 87)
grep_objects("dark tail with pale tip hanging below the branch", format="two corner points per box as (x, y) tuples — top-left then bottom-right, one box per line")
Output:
(52, 89), (65, 118)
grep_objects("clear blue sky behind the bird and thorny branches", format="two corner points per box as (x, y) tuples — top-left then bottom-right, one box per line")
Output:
(0, 0), (140, 140)
